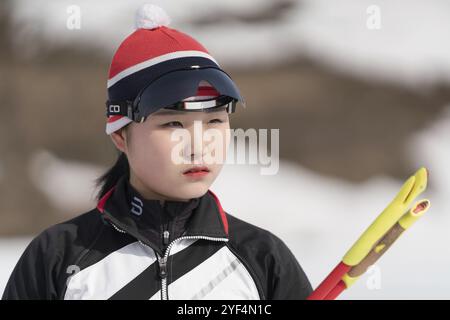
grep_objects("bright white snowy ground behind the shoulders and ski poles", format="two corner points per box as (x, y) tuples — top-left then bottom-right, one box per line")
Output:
(0, 108), (450, 299)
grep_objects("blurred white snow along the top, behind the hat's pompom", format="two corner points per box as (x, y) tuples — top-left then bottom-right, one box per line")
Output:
(8, 0), (450, 87)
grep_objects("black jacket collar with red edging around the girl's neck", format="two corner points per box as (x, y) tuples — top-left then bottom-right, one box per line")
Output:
(97, 175), (228, 247)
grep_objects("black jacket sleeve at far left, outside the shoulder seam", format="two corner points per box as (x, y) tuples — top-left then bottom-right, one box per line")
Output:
(2, 233), (57, 300)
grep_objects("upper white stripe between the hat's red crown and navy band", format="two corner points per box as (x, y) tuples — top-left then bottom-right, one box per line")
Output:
(107, 50), (219, 88)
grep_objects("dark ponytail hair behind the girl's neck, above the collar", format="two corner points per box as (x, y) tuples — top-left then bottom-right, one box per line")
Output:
(95, 150), (130, 200)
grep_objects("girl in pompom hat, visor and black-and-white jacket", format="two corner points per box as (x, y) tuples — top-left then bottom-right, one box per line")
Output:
(3, 5), (312, 299)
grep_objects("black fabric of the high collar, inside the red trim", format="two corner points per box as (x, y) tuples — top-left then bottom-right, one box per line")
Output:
(105, 172), (227, 255)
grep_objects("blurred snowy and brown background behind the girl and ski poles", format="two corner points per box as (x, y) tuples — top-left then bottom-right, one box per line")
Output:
(0, 0), (450, 299)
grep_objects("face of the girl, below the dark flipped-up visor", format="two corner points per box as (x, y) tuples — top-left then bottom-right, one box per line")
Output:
(111, 107), (230, 201)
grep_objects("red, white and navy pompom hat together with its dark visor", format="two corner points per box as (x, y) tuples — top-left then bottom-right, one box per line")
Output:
(106, 4), (245, 135)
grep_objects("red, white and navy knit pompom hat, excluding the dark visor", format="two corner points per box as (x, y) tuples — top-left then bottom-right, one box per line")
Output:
(106, 4), (237, 134)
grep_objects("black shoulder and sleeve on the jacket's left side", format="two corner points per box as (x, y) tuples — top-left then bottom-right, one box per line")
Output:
(3, 209), (136, 300)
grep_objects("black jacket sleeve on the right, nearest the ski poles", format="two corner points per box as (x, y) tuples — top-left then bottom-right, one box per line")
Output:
(268, 237), (313, 300)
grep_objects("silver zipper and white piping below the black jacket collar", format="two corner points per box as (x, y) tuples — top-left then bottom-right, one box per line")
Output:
(108, 220), (228, 300)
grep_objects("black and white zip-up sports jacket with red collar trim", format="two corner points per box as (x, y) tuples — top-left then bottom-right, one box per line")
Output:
(3, 176), (312, 299)
